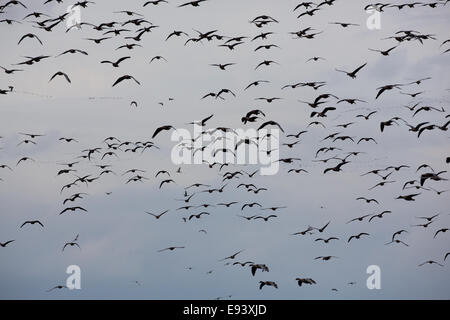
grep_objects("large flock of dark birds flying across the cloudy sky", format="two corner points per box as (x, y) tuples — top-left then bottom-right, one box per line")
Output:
(0, 0), (450, 298)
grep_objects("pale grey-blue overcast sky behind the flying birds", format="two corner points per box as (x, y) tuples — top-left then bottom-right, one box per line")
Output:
(0, 0), (450, 299)
